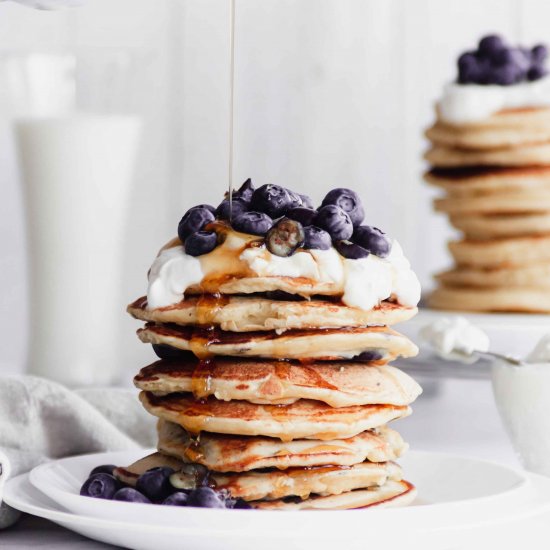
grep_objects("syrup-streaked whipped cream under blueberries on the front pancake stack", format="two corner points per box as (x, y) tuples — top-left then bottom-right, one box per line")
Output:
(147, 232), (420, 310)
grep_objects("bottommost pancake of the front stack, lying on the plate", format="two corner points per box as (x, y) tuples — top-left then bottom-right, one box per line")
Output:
(254, 480), (416, 510)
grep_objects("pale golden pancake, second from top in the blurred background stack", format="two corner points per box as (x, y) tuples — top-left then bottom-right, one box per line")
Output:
(426, 122), (550, 149)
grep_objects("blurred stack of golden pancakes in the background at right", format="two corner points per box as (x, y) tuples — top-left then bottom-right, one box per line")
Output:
(425, 108), (550, 312)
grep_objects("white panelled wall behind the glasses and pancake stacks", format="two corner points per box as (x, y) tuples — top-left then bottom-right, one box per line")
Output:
(0, 0), (550, 371)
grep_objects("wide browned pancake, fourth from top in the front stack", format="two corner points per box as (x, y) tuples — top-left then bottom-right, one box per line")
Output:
(134, 358), (422, 407)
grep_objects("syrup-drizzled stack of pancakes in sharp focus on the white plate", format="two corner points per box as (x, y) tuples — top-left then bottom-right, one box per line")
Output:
(128, 270), (421, 509)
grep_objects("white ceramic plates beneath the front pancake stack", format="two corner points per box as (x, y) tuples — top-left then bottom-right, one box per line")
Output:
(0, 452), (550, 550)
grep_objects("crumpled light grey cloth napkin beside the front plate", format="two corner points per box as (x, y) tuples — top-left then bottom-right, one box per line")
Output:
(0, 376), (156, 529)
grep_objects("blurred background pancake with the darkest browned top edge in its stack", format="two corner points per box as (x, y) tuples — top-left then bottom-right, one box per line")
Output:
(424, 166), (550, 197)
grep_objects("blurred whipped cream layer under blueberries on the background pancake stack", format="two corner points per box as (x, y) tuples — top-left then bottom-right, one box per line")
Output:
(438, 76), (550, 124)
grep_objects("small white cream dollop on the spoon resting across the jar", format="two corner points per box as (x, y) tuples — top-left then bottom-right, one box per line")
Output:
(420, 316), (489, 363)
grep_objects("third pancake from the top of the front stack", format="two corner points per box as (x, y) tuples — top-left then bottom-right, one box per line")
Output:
(137, 324), (418, 362)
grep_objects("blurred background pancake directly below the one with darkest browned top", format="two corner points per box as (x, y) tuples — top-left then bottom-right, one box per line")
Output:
(434, 188), (550, 215)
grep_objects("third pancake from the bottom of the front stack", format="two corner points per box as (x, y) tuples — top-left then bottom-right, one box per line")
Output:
(158, 420), (408, 472)
